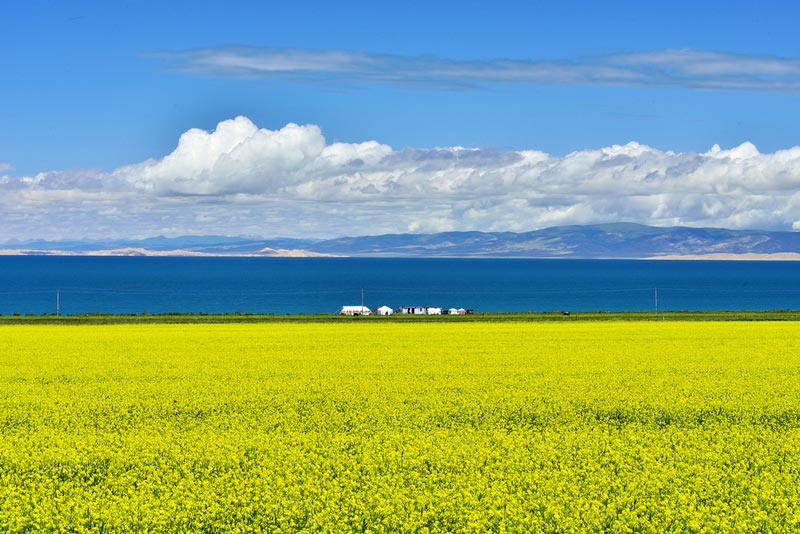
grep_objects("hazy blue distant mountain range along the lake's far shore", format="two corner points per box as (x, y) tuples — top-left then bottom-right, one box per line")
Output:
(0, 223), (800, 258)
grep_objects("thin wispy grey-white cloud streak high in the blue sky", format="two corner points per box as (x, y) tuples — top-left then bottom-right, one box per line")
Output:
(157, 47), (800, 93)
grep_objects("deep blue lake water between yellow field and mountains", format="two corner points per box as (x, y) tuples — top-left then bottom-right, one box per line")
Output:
(0, 256), (800, 315)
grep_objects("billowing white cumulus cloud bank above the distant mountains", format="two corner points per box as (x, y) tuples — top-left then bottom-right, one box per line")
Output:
(0, 117), (800, 239)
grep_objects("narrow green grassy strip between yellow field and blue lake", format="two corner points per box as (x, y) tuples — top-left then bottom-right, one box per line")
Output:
(0, 310), (800, 325)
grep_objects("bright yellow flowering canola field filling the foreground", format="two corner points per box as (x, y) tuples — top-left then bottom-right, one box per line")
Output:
(0, 321), (800, 533)
